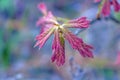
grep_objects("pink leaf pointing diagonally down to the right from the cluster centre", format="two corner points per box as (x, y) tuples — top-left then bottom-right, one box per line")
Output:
(64, 30), (93, 57)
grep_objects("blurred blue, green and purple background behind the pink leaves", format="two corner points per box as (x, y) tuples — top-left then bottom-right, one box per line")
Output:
(0, 0), (120, 80)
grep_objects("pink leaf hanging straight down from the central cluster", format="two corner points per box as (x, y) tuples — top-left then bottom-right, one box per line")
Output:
(51, 31), (65, 66)
